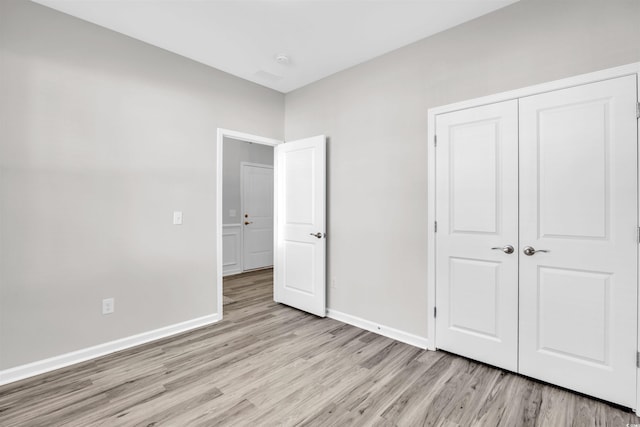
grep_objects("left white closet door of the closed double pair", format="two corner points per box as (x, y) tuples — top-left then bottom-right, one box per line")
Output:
(436, 100), (518, 371)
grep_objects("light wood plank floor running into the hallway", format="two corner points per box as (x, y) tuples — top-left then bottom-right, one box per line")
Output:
(0, 270), (640, 427)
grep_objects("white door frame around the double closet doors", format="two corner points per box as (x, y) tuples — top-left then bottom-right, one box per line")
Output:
(427, 62), (640, 415)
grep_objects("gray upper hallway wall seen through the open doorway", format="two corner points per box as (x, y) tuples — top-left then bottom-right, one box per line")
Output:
(222, 138), (273, 224)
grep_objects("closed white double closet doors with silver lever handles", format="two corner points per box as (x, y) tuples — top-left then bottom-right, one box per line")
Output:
(436, 76), (638, 407)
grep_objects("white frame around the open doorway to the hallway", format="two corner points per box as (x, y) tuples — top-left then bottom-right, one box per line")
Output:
(216, 128), (284, 319)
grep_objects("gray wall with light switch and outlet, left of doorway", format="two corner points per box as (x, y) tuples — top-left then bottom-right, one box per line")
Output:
(0, 0), (284, 369)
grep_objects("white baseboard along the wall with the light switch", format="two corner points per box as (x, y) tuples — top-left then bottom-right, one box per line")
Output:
(0, 313), (222, 385)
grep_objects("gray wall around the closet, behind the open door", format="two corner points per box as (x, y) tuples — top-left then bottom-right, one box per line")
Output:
(285, 0), (640, 337)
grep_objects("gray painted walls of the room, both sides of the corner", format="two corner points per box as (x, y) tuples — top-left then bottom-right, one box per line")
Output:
(0, 0), (640, 369)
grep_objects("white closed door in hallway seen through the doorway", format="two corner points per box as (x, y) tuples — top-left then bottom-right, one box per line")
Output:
(241, 162), (273, 270)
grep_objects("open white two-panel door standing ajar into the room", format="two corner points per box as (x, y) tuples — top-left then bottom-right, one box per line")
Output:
(274, 135), (326, 317)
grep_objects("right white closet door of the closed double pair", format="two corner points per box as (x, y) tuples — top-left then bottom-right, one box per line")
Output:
(519, 76), (638, 407)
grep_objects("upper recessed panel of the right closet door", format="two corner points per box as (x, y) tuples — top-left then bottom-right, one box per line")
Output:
(536, 99), (611, 240)
